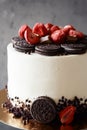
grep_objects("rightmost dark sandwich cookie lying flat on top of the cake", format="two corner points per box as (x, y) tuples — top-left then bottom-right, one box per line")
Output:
(61, 43), (87, 54)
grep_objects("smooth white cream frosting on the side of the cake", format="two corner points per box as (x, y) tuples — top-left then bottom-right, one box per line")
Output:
(7, 43), (87, 102)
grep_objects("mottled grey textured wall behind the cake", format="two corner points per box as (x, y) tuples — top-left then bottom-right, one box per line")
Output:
(0, 0), (87, 87)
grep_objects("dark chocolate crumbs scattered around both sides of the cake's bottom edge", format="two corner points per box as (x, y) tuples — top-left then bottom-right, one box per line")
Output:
(3, 96), (87, 125)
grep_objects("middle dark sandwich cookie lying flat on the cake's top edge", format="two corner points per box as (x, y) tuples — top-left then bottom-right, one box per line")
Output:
(35, 42), (61, 56)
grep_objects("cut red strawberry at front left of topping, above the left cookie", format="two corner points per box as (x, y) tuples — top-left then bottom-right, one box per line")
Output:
(24, 28), (40, 44)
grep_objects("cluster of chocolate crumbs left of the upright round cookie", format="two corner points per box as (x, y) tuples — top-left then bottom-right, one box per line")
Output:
(3, 97), (32, 125)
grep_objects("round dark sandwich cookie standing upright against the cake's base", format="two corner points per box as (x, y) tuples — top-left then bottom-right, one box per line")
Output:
(30, 96), (57, 123)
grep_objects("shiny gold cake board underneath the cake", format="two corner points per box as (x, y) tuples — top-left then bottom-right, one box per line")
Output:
(0, 89), (87, 130)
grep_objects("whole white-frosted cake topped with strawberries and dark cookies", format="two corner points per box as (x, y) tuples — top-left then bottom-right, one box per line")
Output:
(3, 23), (87, 124)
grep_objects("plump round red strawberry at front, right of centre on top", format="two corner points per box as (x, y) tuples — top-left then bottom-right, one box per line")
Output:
(50, 30), (65, 43)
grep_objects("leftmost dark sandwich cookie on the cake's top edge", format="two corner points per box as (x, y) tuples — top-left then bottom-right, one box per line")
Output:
(12, 37), (35, 53)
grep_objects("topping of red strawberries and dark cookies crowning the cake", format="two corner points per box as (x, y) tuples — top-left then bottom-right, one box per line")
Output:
(12, 23), (87, 56)
